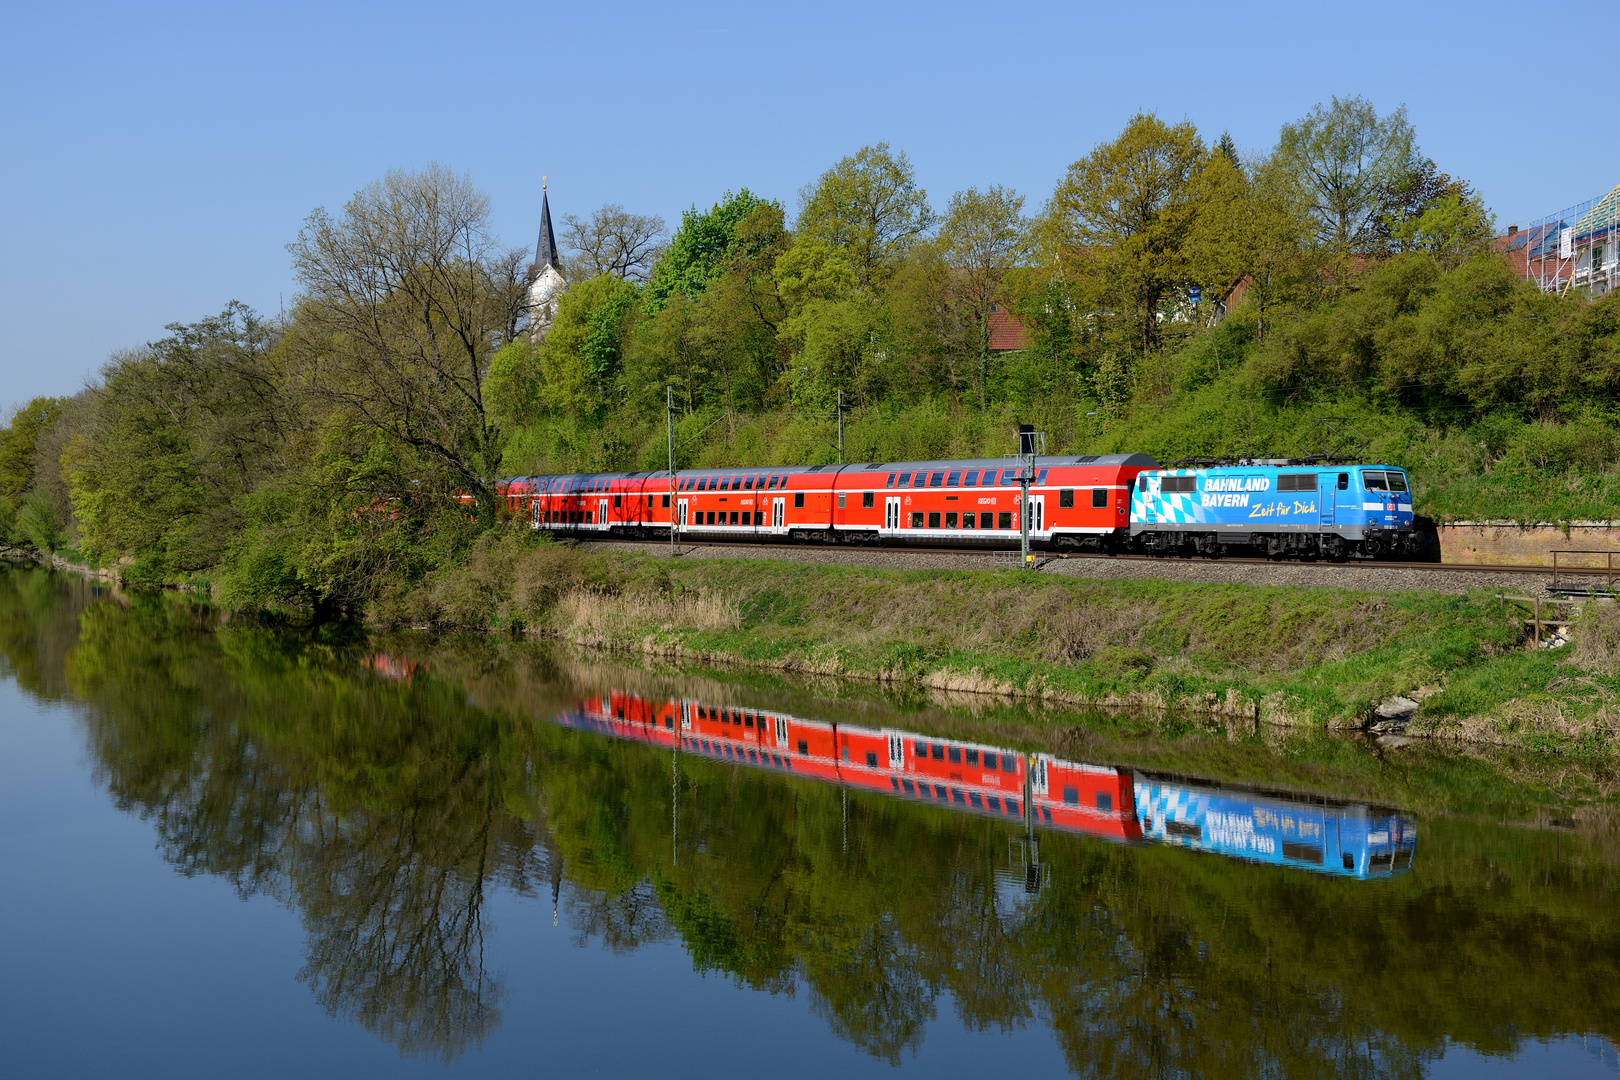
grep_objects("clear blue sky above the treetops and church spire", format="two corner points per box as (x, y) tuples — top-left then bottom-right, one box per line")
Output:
(0, 0), (1620, 408)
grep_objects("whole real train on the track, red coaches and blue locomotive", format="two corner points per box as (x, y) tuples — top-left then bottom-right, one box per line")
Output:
(499, 453), (1418, 559)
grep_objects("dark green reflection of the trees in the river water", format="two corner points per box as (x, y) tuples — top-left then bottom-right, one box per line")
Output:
(9, 572), (1620, 1077)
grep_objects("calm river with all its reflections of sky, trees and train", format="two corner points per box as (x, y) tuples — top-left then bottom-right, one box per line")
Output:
(0, 570), (1620, 1077)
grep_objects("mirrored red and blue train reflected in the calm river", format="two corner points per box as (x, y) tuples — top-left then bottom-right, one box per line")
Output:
(556, 691), (1418, 878)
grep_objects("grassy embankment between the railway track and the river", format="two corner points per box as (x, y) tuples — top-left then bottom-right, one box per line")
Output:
(371, 538), (1620, 750)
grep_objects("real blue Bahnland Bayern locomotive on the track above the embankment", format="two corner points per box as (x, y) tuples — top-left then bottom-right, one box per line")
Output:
(1131, 458), (1416, 559)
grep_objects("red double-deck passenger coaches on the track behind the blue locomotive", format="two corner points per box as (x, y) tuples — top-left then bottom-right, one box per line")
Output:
(501, 453), (1157, 549)
